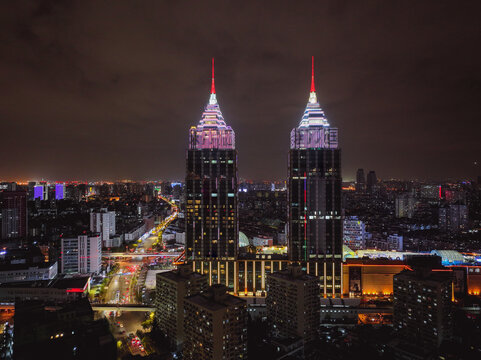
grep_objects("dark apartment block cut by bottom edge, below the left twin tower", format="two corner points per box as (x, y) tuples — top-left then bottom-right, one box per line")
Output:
(183, 284), (247, 360)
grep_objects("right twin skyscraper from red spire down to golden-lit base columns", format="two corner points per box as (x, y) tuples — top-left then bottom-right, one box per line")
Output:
(288, 58), (343, 296)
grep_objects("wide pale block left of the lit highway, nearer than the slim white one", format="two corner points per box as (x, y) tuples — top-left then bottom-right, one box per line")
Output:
(60, 235), (102, 274)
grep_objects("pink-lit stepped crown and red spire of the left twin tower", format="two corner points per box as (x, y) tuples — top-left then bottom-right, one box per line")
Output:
(189, 58), (235, 150)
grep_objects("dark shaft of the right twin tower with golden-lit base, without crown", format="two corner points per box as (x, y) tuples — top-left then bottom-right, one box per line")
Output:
(288, 149), (343, 296)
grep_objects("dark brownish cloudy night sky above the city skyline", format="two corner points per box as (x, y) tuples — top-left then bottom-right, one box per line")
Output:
(0, 0), (481, 180)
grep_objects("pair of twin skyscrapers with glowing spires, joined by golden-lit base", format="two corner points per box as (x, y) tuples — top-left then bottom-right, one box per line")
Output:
(185, 58), (343, 297)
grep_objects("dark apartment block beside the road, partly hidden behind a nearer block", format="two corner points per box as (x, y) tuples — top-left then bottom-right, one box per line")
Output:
(155, 264), (207, 347)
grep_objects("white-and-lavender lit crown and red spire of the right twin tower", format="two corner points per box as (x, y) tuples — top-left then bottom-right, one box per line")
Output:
(291, 56), (338, 149)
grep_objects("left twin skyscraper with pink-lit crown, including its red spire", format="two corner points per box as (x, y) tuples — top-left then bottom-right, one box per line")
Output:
(185, 61), (239, 268)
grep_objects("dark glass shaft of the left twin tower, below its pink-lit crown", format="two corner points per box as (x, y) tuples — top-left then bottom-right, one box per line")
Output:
(185, 149), (239, 260)
